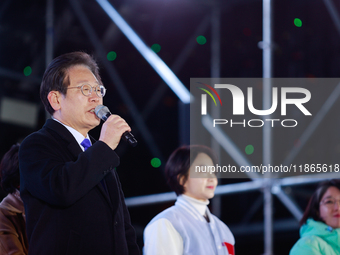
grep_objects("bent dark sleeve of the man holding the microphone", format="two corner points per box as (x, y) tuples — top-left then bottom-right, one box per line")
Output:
(19, 133), (119, 207)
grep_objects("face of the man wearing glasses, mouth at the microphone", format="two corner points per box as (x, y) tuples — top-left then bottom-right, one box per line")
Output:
(53, 65), (103, 136)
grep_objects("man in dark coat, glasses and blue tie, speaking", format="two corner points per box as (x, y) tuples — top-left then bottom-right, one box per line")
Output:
(19, 52), (140, 255)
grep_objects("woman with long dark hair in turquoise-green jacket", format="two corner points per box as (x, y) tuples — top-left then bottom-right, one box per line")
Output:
(289, 179), (340, 255)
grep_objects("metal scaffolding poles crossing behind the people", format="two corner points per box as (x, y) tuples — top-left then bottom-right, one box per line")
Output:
(0, 0), (340, 255)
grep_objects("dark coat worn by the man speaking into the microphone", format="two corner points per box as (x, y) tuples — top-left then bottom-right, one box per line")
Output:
(19, 119), (140, 255)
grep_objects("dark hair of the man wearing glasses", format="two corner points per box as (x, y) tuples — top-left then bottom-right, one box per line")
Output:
(40, 51), (102, 115)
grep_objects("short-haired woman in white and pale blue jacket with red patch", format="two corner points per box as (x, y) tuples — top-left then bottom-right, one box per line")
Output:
(143, 145), (235, 255)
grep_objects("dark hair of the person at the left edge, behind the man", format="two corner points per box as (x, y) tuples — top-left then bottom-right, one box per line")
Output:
(0, 144), (20, 193)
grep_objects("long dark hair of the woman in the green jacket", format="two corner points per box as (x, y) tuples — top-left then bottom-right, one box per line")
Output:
(300, 179), (340, 226)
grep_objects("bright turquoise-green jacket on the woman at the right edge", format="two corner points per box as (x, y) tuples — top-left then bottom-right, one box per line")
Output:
(289, 219), (340, 255)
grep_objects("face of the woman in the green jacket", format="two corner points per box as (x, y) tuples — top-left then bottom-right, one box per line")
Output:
(319, 187), (340, 228)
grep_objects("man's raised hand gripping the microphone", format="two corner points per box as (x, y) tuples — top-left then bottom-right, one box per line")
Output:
(99, 114), (131, 150)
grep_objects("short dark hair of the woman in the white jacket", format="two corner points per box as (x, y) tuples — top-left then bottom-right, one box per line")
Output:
(165, 145), (217, 196)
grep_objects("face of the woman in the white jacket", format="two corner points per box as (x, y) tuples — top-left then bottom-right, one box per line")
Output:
(183, 153), (217, 201)
